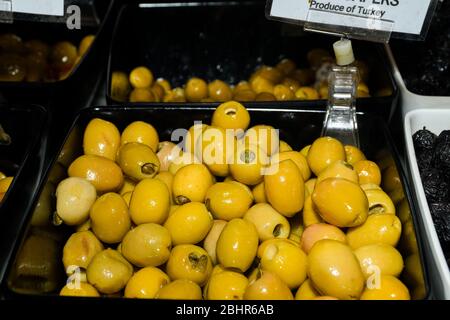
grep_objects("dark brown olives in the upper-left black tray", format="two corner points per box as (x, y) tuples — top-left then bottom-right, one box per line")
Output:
(0, 33), (94, 82)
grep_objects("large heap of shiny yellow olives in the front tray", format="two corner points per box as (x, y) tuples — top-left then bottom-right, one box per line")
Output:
(55, 101), (423, 300)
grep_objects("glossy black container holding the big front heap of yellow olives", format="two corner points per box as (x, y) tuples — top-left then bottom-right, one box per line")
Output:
(0, 105), (430, 303)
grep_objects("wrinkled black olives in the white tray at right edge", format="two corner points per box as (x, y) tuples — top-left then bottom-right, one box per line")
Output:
(413, 128), (450, 252)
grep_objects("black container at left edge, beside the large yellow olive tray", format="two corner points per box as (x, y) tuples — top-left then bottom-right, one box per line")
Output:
(0, 104), (48, 282)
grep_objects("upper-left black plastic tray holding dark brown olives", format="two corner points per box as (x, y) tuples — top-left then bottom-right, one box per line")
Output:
(0, 0), (117, 108)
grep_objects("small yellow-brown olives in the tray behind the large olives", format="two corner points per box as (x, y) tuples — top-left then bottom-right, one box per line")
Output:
(111, 49), (370, 102)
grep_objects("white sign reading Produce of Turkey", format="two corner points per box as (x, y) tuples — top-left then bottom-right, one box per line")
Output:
(268, 0), (436, 36)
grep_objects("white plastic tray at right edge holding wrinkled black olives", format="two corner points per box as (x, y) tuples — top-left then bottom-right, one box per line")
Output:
(404, 109), (450, 300)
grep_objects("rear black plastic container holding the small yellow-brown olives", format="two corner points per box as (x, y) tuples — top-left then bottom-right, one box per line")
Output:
(107, 1), (398, 119)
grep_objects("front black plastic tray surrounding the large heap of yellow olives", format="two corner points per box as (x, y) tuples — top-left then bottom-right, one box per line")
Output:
(0, 105), (430, 301)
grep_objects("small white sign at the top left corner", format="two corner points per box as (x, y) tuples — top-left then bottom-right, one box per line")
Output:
(12, 0), (64, 16)
